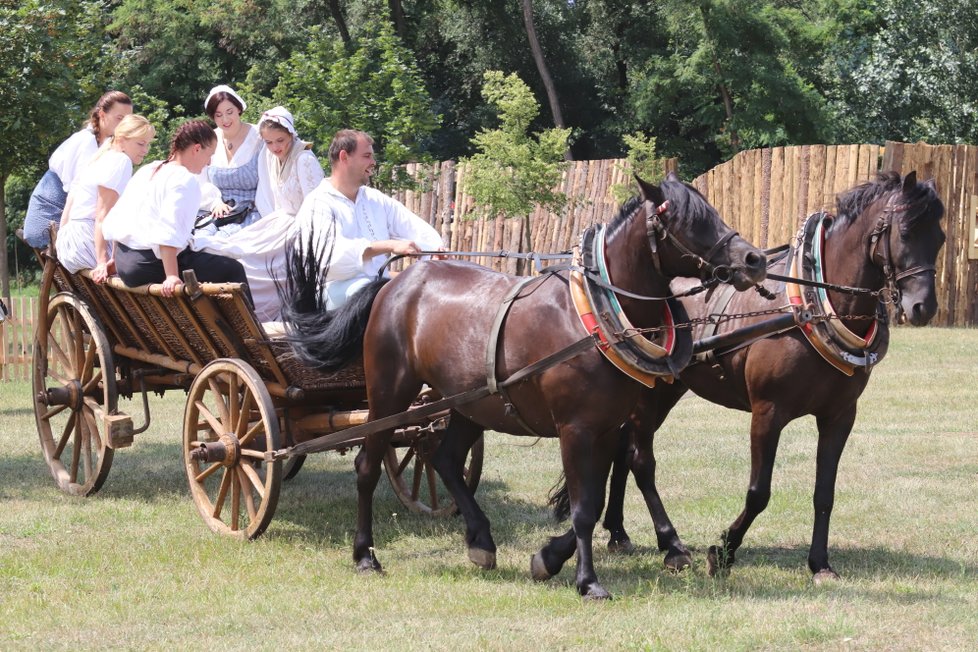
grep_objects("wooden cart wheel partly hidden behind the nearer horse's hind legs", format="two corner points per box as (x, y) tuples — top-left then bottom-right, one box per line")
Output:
(384, 433), (485, 516)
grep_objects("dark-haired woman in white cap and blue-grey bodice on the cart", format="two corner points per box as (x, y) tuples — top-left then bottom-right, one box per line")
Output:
(200, 84), (262, 235)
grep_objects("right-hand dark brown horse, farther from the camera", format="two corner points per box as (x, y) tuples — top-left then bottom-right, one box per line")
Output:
(551, 172), (944, 581)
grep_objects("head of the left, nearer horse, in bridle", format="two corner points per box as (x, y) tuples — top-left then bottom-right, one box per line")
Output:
(636, 172), (767, 290)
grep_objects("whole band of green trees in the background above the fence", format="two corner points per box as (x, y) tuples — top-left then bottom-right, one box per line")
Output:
(0, 0), (978, 284)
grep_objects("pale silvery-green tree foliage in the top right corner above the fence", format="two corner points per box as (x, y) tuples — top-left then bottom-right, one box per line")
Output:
(823, 0), (978, 143)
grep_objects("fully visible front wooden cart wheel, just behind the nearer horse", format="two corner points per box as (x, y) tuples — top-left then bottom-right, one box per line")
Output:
(183, 359), (282, 539)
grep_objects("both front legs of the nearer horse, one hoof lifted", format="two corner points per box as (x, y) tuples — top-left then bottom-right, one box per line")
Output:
(530, 429), (618, 600)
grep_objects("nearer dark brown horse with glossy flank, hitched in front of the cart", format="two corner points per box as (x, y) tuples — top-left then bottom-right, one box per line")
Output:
(286, 172), (766, 598)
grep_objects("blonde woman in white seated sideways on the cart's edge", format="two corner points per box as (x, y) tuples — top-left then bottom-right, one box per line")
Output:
(57, 115), (156, 283)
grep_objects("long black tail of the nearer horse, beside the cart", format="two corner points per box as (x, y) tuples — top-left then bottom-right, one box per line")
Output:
(275, 220), (389, 371)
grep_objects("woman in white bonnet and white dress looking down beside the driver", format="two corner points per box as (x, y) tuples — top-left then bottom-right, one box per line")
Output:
(193, 106), (325, 321)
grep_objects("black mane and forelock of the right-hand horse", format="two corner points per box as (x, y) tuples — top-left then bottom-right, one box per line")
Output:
(834, 171), (944, 233)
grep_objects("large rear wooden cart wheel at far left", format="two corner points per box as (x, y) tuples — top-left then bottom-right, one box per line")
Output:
(32, 294), (118, 496)
